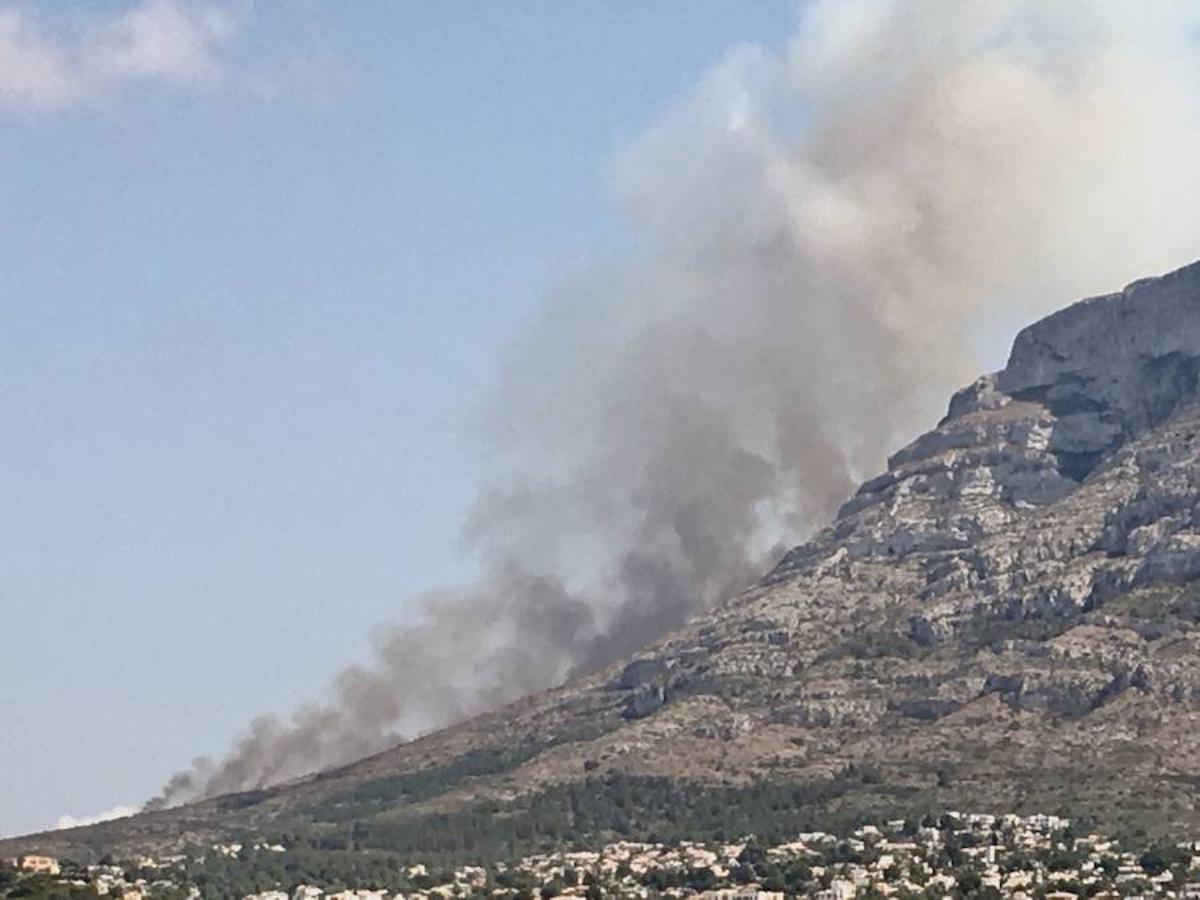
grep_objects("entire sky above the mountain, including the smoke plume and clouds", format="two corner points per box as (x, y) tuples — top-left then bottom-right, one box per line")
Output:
(14, 0), (1185, 834)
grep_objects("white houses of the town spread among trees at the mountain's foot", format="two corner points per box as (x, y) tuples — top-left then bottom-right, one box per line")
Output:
(12, 812), (1200, 900)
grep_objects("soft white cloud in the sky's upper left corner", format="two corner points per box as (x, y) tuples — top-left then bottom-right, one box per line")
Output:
(0, 0), (236, 110)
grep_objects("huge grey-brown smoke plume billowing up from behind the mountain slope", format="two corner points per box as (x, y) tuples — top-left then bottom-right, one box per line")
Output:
(158, 0), (1200, 803)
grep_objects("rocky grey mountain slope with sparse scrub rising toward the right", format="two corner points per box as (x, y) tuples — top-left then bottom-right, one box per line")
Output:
(11, 263), (1200, 858)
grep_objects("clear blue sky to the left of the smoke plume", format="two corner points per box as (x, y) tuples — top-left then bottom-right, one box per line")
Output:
(0, 0), (797, 834)
